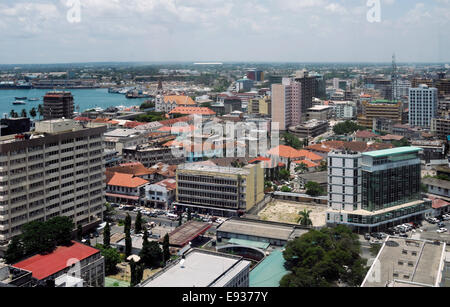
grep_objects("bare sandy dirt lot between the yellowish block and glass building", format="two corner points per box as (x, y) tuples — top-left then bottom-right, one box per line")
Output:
(258, 200), (327, 226)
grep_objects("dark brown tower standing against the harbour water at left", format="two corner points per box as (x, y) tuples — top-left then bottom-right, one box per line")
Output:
(44, 92), (74, 120)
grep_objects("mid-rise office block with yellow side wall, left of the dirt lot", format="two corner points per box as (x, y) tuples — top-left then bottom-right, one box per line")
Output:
(174, 163), (264, 216)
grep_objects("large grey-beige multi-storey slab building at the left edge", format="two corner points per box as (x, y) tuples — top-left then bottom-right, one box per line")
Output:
(0, 119), (106, 253)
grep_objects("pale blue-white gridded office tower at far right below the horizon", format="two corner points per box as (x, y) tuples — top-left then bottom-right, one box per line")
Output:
(409, 84), (438, 128)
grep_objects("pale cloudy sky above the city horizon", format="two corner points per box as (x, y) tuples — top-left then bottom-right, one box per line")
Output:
(0, 0), (450, 64)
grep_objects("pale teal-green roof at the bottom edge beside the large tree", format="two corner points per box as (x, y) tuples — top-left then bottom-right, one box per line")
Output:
(250, 249), (289, 288)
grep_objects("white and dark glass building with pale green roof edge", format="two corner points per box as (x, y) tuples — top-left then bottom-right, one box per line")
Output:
(327, 147), (432, 231)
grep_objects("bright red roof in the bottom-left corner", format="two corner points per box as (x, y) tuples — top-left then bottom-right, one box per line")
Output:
(13, 241), (100, 280)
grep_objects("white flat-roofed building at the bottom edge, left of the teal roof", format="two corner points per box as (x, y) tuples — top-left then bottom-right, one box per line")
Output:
(139, 249), (251, 288)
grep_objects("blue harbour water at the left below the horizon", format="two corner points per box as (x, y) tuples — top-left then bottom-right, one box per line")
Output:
(0, 89), (146, 118)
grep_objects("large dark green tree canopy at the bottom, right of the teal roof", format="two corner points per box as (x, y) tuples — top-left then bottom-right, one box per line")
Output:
(280, 225), (367, 287)
